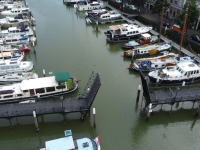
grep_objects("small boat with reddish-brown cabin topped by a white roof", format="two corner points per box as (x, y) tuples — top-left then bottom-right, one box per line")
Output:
(122, 33), (158, 49)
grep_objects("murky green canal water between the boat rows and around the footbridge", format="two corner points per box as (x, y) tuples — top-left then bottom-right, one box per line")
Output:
(0, 0), (200, 150)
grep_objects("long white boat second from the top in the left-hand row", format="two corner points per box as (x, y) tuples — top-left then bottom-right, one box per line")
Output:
(0, 7), (29, 16)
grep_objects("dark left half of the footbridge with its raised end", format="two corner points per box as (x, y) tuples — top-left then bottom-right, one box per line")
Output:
(0, 73), (101, 126)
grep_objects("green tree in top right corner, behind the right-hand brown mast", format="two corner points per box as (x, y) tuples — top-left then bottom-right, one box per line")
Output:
(176, 0), (200, 29)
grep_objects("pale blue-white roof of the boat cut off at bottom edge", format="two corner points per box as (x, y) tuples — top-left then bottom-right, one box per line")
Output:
(45, 136), (75, 150)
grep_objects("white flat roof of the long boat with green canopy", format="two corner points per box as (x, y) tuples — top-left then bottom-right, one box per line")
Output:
(21, 76), (58, 90)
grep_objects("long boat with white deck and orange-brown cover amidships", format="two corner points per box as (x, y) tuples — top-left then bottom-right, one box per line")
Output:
(123, 43), (172, 58)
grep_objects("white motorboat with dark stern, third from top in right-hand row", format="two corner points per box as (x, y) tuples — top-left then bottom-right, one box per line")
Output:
(86, 11), (121, 24)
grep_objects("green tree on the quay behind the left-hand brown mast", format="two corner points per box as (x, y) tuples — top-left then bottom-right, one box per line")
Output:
(151, 0), (171, 20)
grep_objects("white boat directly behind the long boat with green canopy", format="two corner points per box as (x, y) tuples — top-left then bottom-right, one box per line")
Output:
(0, 72), (38, 84)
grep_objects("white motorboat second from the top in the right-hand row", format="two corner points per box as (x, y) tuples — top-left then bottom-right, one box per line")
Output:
(74, 1), (108, 11)
